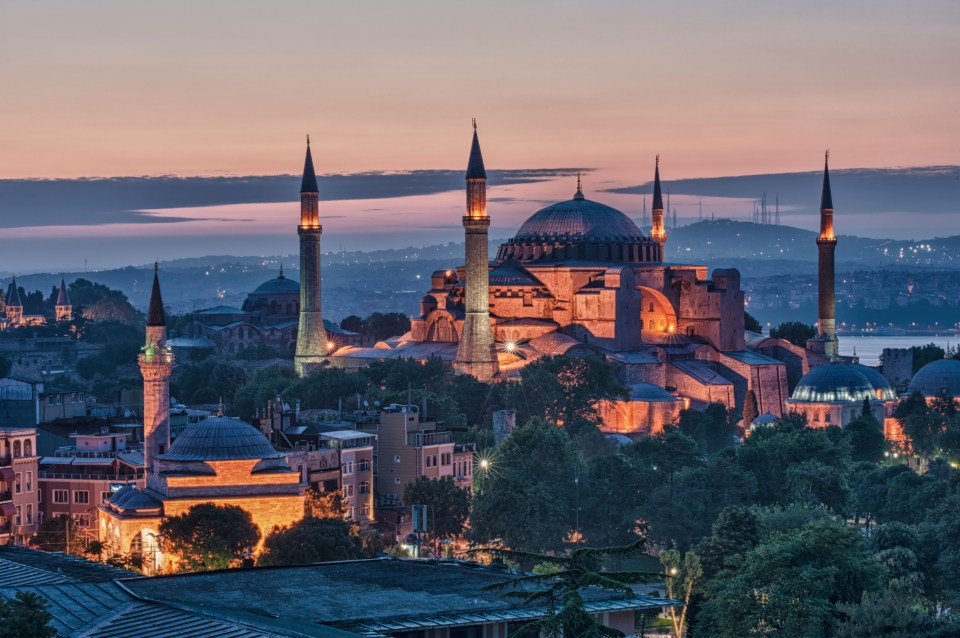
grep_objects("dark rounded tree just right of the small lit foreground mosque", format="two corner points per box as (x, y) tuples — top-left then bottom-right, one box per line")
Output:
(259, 517), (363, 565)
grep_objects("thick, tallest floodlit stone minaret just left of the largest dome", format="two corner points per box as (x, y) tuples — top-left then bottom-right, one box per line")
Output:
(453, 120), (500, 381)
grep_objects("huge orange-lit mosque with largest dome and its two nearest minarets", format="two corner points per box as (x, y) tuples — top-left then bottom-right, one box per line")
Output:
(330, 135), (800, 435)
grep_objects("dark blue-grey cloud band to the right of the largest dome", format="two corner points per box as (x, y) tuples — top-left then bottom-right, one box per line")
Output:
(607, 166), (960, 214)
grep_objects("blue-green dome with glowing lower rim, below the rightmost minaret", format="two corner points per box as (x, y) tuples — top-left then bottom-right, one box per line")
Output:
(790, 363), (896, 403)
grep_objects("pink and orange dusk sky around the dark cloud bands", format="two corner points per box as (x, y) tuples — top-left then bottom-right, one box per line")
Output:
(0, 0), (960, 272)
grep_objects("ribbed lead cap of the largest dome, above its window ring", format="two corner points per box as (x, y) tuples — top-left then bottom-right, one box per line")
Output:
(514, 198), (644, 242)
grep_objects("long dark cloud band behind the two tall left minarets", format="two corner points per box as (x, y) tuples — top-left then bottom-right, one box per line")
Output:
(0, 168), (583, 228)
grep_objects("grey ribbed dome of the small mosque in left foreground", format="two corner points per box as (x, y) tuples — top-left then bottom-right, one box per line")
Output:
(160, 416), (283, 461)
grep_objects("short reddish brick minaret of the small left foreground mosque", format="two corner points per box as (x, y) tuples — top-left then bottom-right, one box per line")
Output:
(139, 264), (173, 491)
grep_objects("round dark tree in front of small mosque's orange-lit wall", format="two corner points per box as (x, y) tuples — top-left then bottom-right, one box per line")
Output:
(160, 503), (260, 571)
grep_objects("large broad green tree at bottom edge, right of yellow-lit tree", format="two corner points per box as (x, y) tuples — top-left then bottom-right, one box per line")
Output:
(697, 520), (884, 637)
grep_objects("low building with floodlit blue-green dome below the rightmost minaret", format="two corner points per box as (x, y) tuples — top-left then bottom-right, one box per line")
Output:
(787, 361), (903, 441)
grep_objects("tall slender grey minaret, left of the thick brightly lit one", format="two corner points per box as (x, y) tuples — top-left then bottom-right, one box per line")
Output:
(294, 135), (327, 376)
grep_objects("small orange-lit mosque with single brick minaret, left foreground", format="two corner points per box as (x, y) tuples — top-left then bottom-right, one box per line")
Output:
(99, 278), (304, 573)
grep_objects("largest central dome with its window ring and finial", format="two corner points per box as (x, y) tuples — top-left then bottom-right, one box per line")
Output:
(497, 189), (663, 263)
